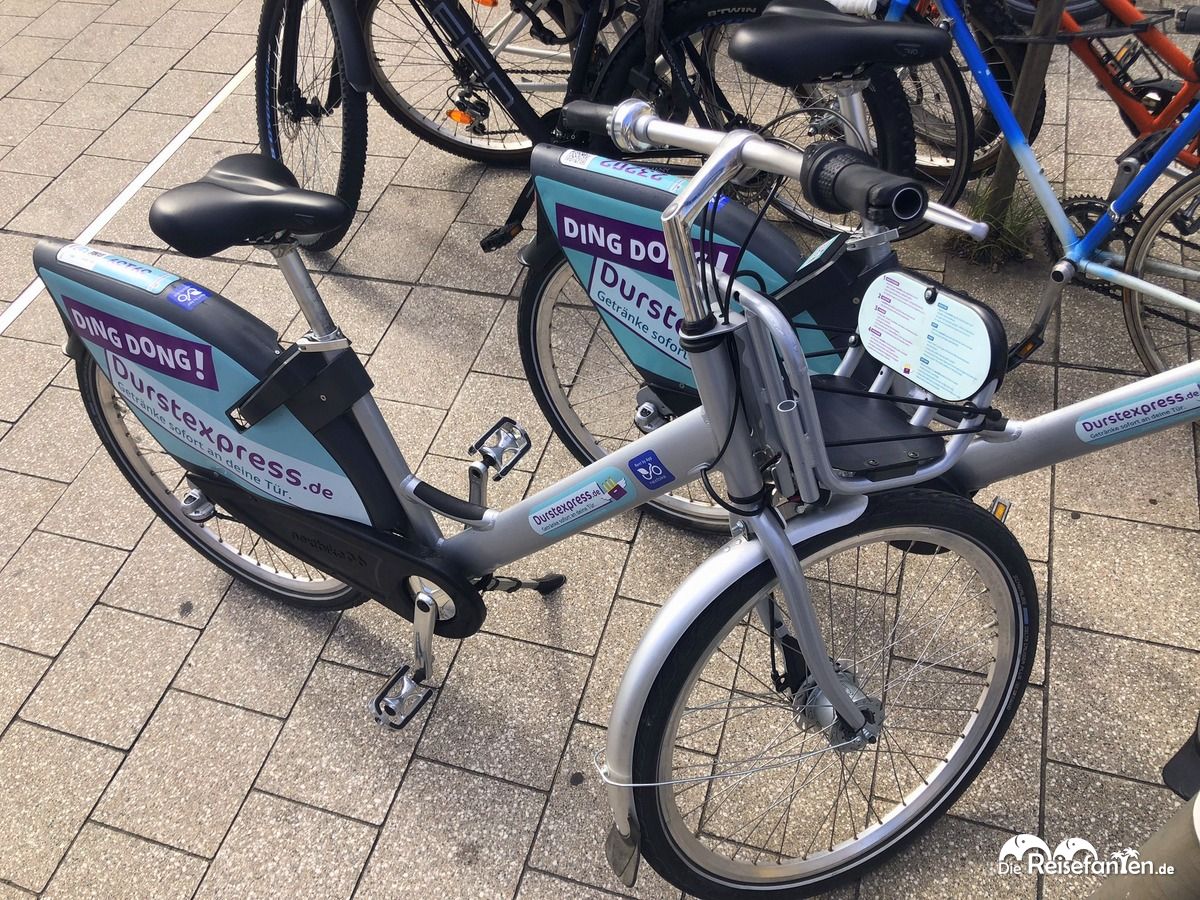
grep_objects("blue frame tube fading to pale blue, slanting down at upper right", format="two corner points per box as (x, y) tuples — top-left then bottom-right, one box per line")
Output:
(887, 0), (1080, 251)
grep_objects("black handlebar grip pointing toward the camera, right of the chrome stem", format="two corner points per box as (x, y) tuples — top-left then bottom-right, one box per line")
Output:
(800, 142), (929, 228)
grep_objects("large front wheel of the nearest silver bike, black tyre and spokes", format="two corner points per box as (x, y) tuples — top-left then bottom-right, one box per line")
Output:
(632, 491), (1038, 898)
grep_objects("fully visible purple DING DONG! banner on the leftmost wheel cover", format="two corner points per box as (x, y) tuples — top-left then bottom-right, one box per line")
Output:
(62, 296), (217, 391)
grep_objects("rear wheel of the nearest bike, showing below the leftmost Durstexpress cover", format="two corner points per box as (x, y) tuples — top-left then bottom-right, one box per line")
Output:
(76, 354), (367, 611)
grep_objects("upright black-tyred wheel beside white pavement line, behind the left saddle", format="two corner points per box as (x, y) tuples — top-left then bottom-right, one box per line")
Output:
(254, 0), (367, 252)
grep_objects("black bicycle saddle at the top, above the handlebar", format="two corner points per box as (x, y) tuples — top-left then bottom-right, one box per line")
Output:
(730, 0), (950, 88)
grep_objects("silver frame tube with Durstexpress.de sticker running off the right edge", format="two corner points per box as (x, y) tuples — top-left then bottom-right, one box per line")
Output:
(950, 361), (1200, 491)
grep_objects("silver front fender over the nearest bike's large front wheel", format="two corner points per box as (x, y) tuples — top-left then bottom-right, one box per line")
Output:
(605, 494), (868, 886)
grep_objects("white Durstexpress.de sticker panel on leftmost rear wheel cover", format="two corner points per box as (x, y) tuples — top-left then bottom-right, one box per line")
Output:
(106, 350), (368, 522)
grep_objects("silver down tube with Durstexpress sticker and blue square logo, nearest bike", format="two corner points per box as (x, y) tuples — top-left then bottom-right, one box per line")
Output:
(438, 408), (716, 576)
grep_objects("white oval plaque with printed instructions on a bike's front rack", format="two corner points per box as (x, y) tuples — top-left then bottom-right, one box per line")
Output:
(858, 272), (991, 401)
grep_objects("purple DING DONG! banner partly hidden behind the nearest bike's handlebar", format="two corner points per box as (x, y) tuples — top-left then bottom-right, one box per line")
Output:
(557, 204), (737, 280)
